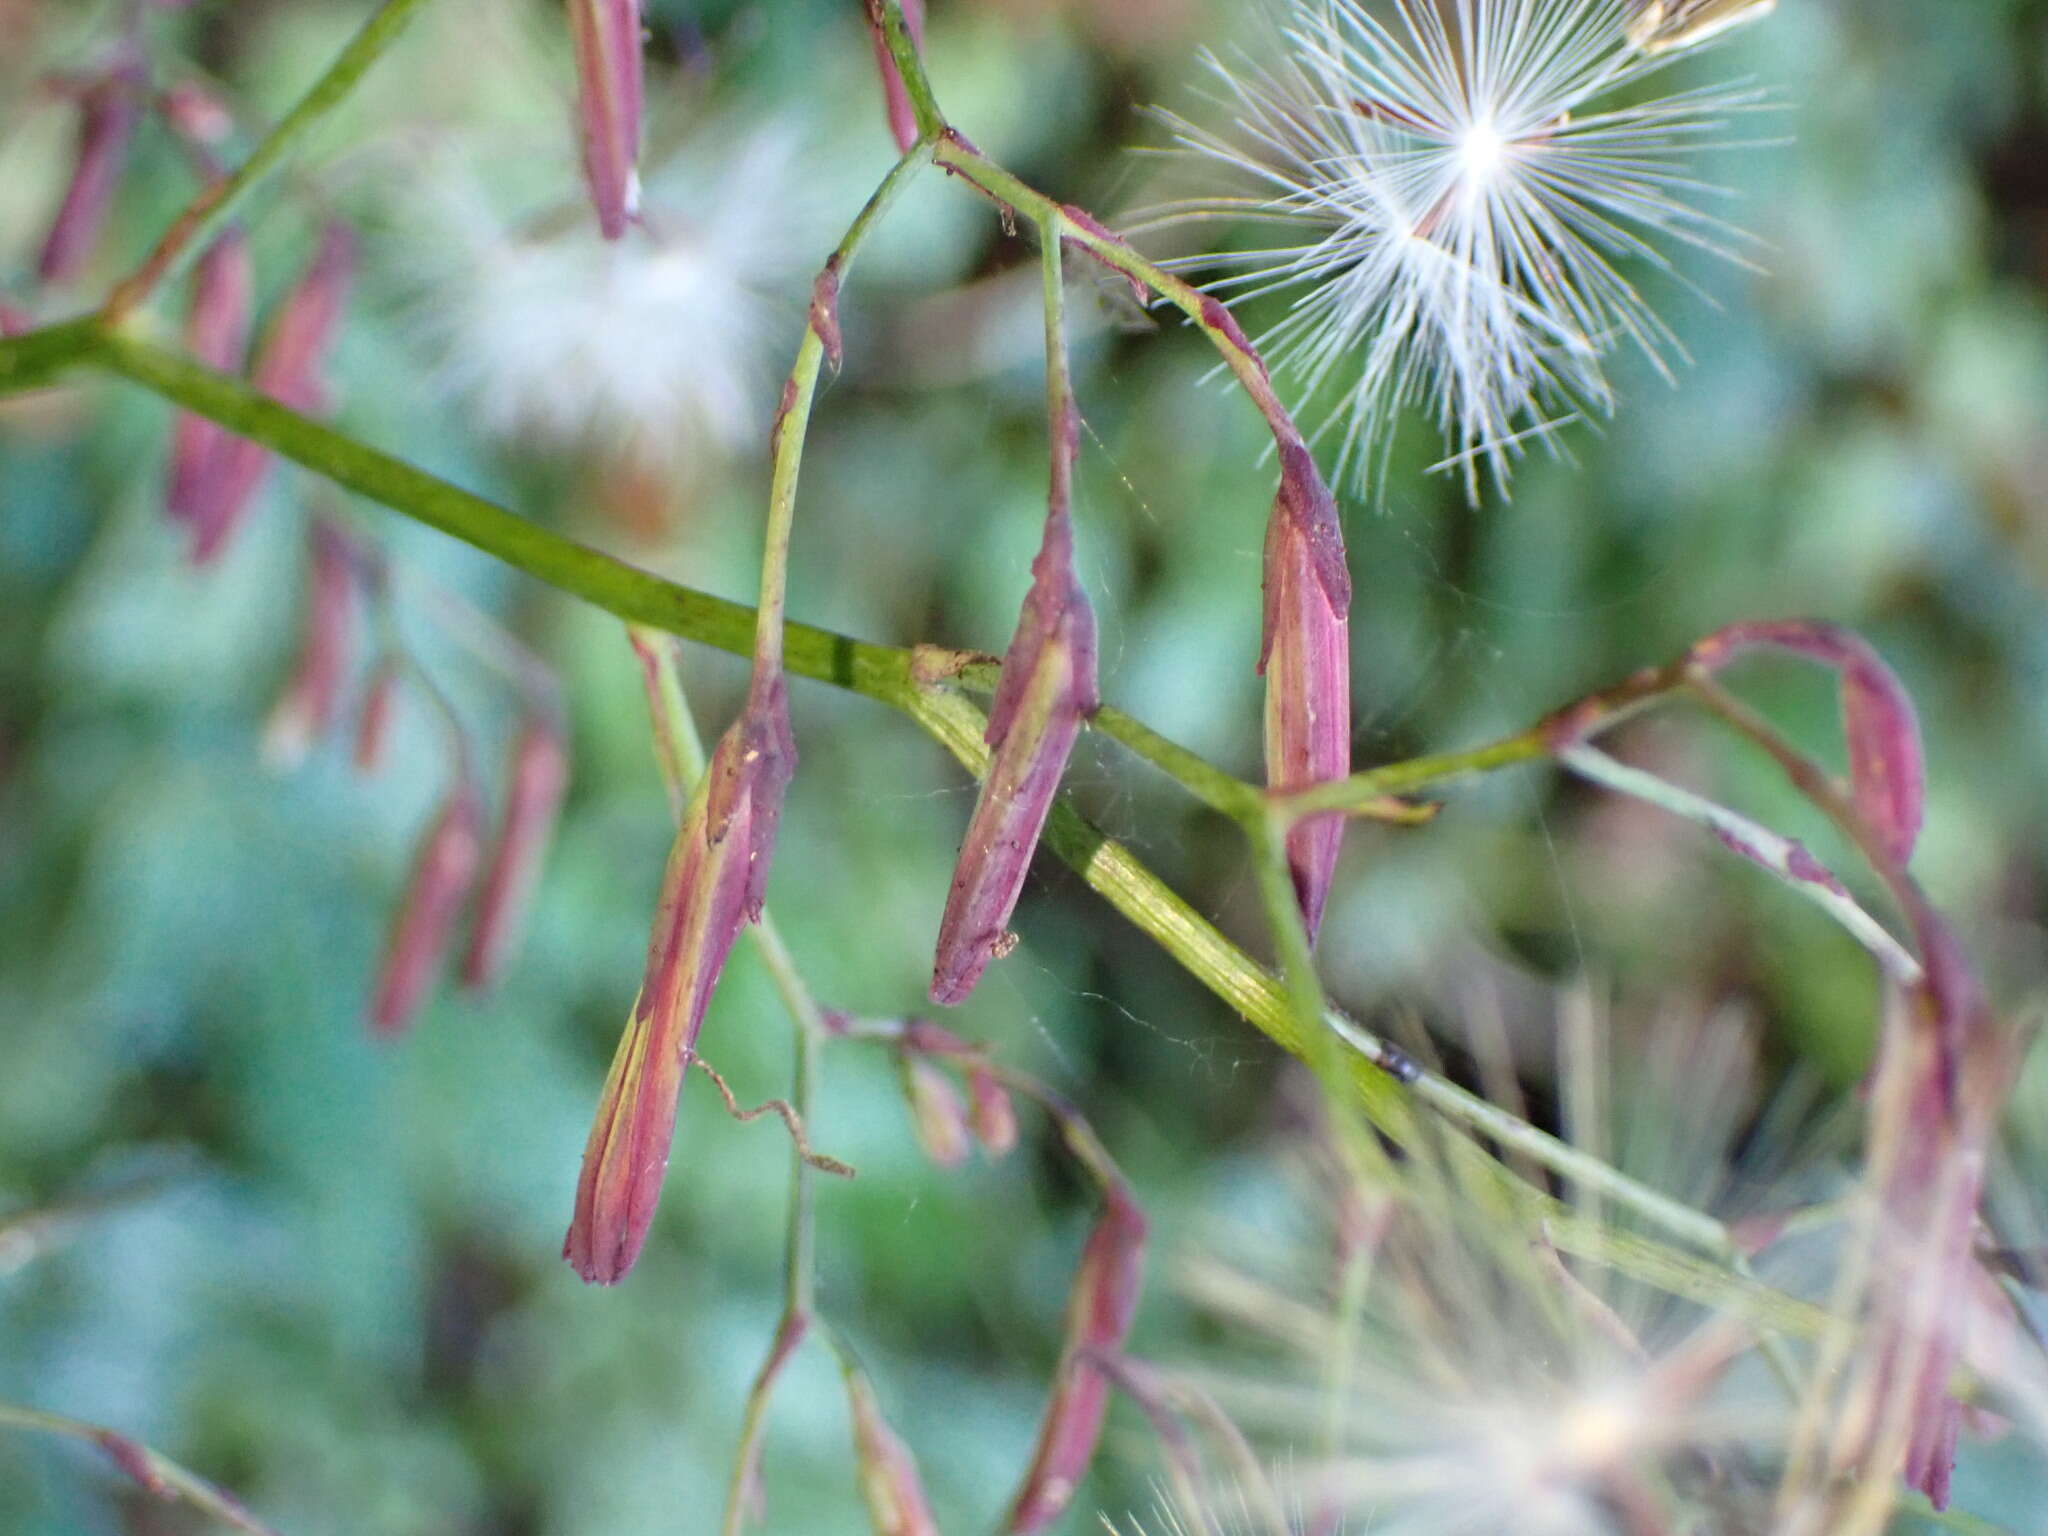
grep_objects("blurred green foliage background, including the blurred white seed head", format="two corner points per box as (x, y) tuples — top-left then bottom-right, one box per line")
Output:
(0, 0), (2048, 1536)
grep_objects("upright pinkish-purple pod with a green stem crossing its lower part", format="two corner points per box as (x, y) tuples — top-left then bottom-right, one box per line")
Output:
(1260, 442), (1352, 942)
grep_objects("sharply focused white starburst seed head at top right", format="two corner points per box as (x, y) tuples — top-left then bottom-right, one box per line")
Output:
(1141, 0), (1757, 500)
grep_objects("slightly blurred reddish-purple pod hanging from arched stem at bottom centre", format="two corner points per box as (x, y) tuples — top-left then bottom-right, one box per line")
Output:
(1004, 1186), (1145, 1536)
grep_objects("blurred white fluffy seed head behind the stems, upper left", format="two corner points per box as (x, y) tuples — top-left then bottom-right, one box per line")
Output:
(395, 127), (817, 471)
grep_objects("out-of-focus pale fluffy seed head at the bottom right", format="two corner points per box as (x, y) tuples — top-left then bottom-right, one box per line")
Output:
(1118, 995), (1826, 1536)
